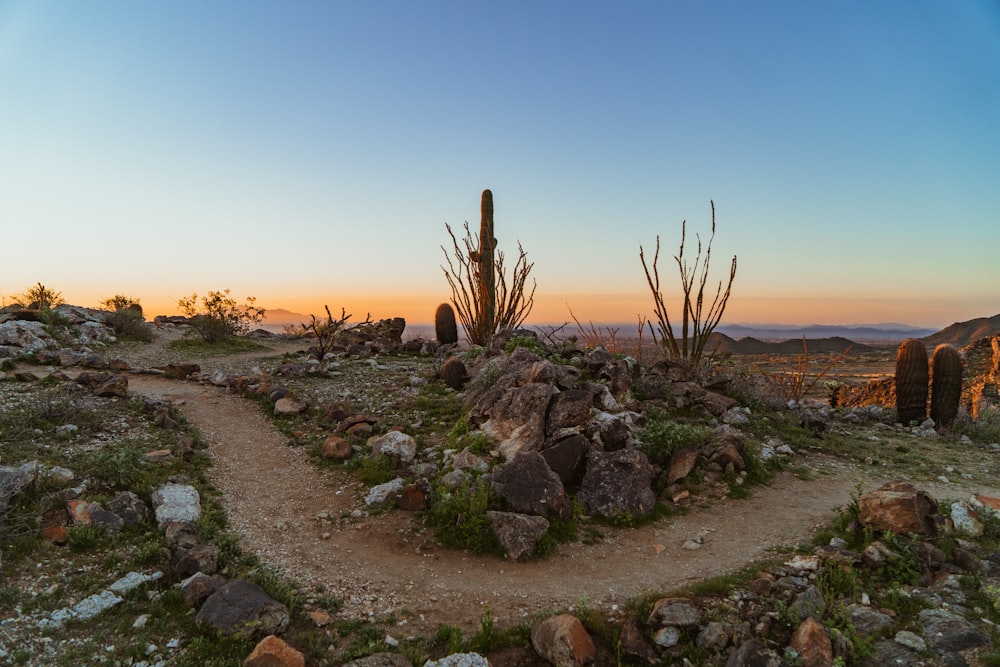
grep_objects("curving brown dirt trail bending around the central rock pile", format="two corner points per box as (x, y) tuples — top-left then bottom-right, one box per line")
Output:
(129, 375), (874, 634)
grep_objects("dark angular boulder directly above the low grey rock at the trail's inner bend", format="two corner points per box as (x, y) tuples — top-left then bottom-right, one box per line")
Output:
(492, 451), (573, 519)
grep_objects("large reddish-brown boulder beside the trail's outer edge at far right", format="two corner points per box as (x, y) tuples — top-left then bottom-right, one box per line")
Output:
(858, 482), (940, 537)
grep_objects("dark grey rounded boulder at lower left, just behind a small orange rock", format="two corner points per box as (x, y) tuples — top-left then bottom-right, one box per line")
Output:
(195, 581), (288, 637)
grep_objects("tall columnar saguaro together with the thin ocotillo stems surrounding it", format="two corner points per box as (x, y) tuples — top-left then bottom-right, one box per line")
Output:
(441, 190), (535, 345)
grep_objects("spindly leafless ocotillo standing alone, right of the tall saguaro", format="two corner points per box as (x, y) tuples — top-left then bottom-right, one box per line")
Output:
(639, 201), (736, 359)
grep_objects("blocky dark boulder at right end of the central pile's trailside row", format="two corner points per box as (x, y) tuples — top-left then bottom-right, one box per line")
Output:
(577, 449), (656, 517)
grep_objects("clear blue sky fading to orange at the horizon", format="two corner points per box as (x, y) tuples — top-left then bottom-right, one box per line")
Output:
(0, 0), (1000, 327)
